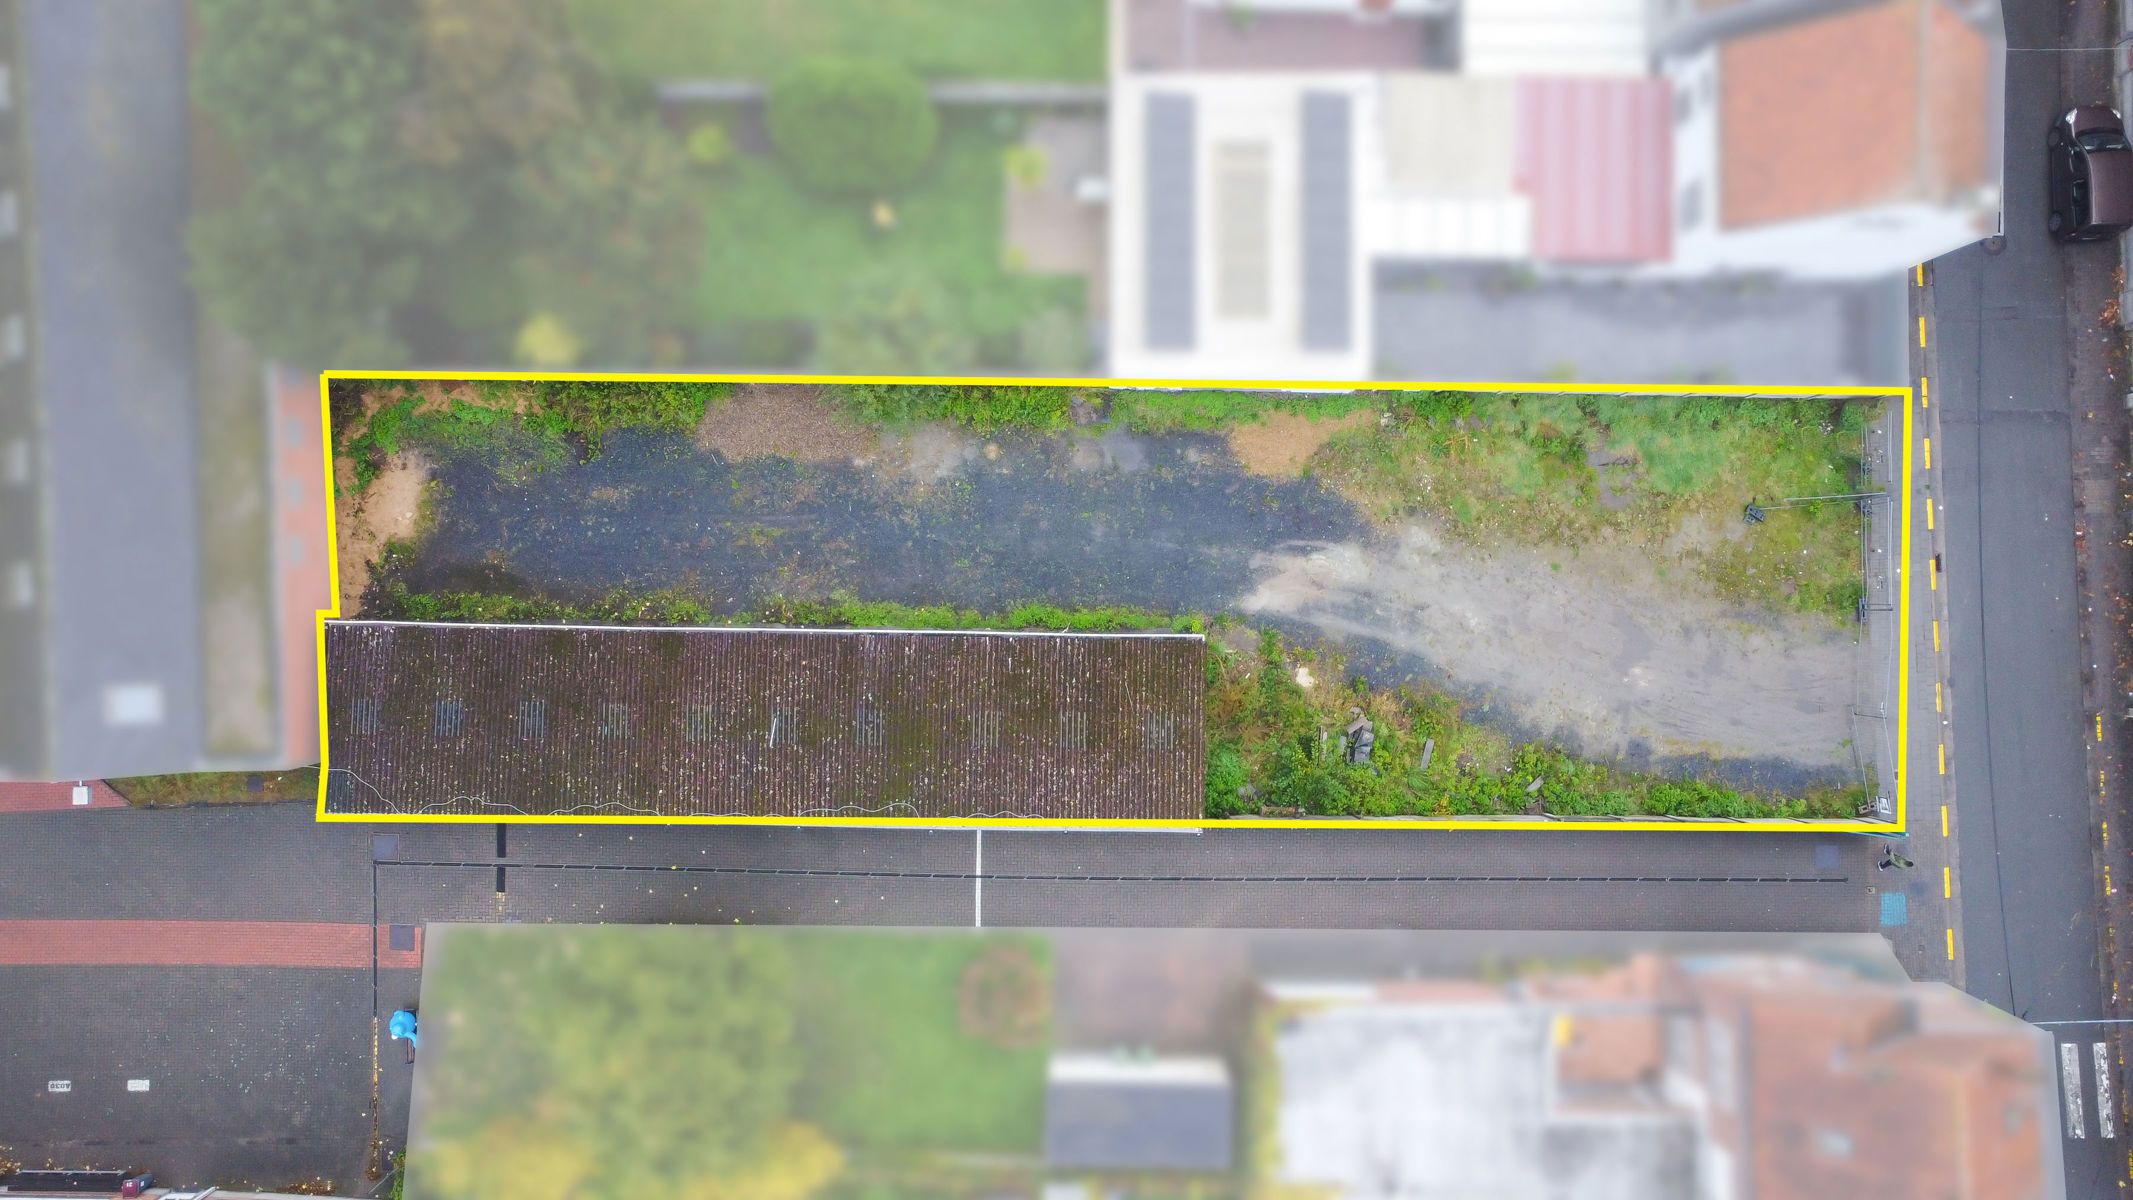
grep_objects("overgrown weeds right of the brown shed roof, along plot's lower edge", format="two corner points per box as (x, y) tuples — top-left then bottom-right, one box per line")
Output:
(1207, 631), (1864, 818)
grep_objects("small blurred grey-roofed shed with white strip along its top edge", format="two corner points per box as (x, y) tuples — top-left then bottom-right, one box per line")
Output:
(1045, 1061), (1235, 1170)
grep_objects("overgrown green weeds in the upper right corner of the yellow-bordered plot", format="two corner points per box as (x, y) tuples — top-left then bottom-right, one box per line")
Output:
(1312, 392), (1877, 616)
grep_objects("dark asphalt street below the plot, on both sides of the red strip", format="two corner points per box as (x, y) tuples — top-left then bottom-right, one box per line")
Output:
(0, 806), (1879, 1187)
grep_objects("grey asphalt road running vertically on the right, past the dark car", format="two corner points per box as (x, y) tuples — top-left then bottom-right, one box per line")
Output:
(1913, 0), (2127, 1196)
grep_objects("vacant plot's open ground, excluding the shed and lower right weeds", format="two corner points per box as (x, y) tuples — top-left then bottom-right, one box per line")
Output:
(343, 384), (1875, 806)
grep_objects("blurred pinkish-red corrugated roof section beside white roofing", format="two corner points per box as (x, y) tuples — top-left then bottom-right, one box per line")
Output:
(1519, 79), (1674, 262)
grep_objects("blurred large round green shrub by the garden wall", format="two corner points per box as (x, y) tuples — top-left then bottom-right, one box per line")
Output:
(764, 58), (941, 196)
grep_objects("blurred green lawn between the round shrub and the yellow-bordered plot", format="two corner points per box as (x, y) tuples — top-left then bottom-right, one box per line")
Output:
(697, 113), (1084, 351)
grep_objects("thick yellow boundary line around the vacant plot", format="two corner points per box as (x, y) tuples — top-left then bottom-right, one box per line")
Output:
(318, 371), (1913, 833)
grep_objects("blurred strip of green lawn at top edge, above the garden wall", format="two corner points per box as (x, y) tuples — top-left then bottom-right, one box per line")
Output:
(570, 0), (1103, 83)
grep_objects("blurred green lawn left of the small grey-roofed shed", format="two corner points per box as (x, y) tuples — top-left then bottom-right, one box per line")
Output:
(781, 929), (1052, 1153)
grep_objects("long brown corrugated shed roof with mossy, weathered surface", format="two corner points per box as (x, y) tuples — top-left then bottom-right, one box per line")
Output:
(326, 620), (1205, 821)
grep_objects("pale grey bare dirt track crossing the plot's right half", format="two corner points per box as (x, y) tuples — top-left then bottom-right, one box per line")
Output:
(1235, 524), (1856, 767)
